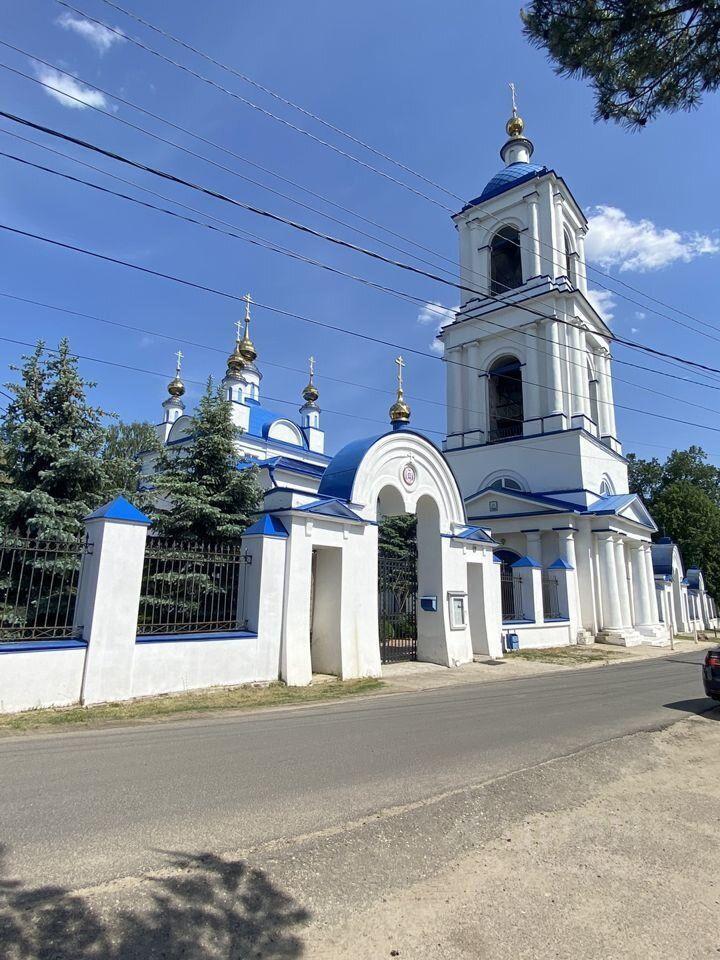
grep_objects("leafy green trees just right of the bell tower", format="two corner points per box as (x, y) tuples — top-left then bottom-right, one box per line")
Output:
(628, 446), (720, 596)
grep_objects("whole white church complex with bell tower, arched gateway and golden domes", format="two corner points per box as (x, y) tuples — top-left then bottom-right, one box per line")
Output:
(146, 101), (715, 683)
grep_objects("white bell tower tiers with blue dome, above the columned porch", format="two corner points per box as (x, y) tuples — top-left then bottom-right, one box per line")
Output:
(440, 97), (627, 510)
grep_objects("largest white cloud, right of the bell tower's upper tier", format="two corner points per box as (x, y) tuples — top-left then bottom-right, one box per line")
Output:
(585, 206), (720, 272)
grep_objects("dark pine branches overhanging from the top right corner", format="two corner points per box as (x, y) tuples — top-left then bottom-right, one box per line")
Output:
(521, 0), (720, 128)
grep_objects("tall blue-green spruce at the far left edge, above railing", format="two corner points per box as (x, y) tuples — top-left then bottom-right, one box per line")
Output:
(0, 339), (106, 539)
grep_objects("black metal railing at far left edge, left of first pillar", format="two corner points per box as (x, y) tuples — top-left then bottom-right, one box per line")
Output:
(0, 530), (91, 643)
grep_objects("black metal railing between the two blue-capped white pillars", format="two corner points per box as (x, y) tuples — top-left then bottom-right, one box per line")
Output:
(138, 537), (251, 636)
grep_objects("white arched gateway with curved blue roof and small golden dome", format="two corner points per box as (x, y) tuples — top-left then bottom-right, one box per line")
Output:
(244, 421), (501, 683)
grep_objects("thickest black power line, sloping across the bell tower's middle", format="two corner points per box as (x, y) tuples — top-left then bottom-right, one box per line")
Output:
(5, 110), (720, 384)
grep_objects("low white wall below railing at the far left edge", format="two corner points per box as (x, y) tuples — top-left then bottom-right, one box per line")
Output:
(0, 647), (86, 713)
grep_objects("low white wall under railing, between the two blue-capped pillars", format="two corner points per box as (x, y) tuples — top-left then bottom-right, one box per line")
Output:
(131, 636), (270, 697)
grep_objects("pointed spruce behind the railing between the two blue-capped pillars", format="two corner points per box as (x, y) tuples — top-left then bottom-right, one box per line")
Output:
(154, 380), (261, 542)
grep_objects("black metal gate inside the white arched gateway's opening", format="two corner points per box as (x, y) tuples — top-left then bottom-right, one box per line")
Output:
(378, 555), (417, 663)
